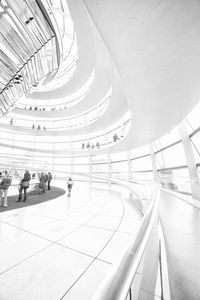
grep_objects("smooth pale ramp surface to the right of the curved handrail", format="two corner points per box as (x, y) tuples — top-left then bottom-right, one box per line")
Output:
(160, 191), (200, 300)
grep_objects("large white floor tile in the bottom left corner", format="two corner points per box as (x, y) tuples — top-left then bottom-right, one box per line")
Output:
(0, 245), (92, 300)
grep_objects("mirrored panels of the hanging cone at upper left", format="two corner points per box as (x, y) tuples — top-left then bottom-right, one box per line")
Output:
(0, 0), (59, 117)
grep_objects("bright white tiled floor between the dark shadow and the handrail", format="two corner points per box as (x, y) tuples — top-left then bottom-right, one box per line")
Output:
(0, 182), (141, 300)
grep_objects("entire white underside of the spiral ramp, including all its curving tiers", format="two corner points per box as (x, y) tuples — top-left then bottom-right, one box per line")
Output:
(1, 0), (200, 152)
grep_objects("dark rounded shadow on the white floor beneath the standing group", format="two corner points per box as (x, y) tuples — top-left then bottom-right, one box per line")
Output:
(0, 187), (66, 212)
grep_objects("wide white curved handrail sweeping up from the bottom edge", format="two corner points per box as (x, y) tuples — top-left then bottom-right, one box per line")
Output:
(91, 186), (159, 300)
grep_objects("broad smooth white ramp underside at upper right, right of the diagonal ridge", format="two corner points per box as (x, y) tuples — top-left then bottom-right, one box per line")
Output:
(82, 0), (200, 149)
